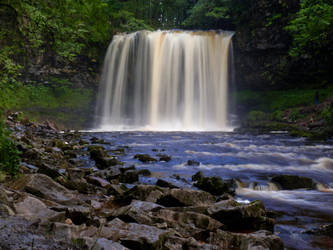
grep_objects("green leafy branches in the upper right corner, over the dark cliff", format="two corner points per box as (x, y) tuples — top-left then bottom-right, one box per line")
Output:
(286, 0), (333, 58)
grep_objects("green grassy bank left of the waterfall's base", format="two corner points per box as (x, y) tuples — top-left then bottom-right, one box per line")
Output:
(0, 82), (93, 128)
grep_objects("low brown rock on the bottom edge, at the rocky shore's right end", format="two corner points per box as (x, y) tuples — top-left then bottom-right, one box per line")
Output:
(207, 230), (284, 250)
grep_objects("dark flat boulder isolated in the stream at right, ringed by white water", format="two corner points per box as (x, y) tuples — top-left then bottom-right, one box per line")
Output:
(272, 175), (316, 190)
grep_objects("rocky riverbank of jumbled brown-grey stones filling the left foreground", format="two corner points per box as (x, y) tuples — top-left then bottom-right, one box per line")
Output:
(0, 115), (283, 249)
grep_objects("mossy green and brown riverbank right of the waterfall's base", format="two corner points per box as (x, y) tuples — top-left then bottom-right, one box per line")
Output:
(236, 89), (333, 140)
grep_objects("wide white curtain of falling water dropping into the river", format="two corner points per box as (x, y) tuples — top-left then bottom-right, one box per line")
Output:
(97, 31), (233, 131)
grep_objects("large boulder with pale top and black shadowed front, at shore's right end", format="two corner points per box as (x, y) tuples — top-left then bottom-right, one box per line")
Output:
(207, 199), (274, 231)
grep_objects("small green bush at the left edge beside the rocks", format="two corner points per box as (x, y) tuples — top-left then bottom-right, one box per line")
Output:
(0, 115), (20, 177)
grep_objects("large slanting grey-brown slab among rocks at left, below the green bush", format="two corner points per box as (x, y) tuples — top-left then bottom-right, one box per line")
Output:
(10, 174), (78, 204)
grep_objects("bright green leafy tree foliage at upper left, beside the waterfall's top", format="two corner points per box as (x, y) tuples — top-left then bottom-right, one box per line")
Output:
(8, 0), (109, 62)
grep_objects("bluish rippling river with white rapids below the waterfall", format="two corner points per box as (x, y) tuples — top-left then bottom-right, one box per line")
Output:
(81, 131), (333, 249)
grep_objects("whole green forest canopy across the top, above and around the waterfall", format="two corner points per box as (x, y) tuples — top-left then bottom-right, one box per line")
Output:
(0, 0), (333, 80)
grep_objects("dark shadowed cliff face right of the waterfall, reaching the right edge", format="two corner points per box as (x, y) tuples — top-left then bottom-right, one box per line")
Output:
(234, 0), (333, 90)
